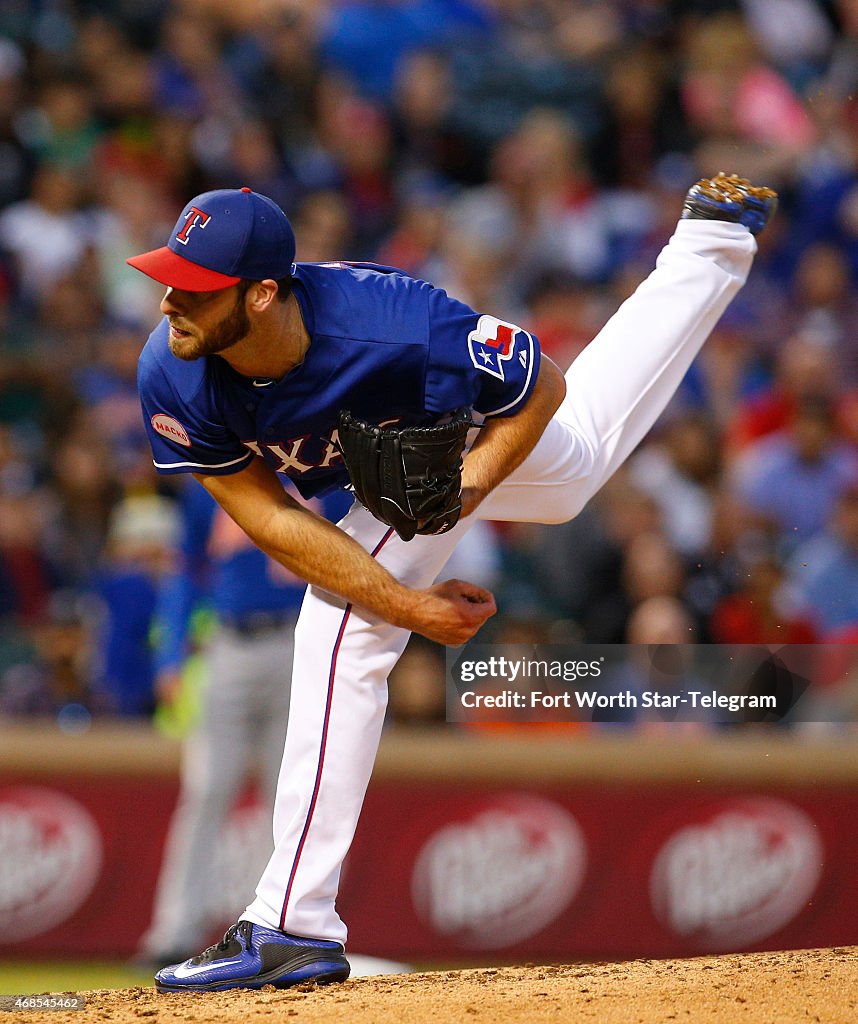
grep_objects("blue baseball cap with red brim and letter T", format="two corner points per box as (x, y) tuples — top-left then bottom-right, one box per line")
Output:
(126, 187), (295, 292)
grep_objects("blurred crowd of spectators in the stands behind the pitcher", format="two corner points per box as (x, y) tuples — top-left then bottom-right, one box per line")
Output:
(0, 0), (858, 728)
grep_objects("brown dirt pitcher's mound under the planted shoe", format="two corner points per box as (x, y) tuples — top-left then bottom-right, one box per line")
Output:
(13, 946), (858, 1024)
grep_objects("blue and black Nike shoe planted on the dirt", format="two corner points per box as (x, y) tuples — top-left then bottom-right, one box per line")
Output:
(155, 921), (349, 992)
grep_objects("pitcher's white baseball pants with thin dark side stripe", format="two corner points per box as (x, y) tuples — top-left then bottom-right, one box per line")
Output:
(243, 220), (757, 942)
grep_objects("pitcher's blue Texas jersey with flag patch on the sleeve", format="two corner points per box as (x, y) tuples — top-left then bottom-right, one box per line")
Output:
(138, 263), (540, 498)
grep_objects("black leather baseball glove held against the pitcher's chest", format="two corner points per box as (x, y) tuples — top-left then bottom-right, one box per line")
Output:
(337, 411), (474, 541)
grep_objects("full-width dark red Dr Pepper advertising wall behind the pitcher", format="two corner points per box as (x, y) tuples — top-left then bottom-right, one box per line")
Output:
(0, 740), (858, 963)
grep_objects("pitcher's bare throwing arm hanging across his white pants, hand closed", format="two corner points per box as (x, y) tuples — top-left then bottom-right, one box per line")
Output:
(195, 459), (497, 645)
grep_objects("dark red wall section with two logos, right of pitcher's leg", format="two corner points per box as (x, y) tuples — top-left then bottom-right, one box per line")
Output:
(341, 783), (858, 961)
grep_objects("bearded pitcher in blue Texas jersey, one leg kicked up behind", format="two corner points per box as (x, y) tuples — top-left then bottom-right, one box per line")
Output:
(128, 175), (776, 991)
